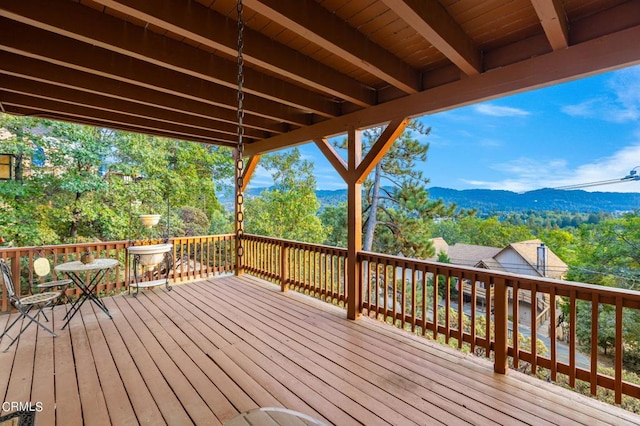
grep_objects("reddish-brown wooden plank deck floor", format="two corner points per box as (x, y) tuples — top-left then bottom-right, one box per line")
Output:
(0, 276), (640, 426)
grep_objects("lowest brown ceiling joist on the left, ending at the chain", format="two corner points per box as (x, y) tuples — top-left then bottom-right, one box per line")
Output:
(0, 95), (238, 144)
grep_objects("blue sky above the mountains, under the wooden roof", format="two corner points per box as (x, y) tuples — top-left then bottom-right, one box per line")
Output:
(251, 66), (640, 192)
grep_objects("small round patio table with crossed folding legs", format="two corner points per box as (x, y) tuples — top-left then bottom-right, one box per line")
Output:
(54, 259), (120, 329)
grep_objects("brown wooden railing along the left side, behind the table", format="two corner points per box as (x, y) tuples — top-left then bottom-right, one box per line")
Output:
(0, 234), (235, 312)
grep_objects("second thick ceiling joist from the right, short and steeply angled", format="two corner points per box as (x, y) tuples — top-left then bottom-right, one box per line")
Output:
(382, 0), (482, 75)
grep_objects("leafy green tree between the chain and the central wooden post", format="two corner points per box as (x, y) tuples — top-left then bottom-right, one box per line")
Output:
(245, 148), (327, 243)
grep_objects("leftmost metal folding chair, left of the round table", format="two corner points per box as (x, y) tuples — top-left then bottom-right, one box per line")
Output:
(0, 259), (61, 352)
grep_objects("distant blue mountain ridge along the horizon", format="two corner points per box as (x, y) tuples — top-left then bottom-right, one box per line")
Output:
(224, 187), (640, 215)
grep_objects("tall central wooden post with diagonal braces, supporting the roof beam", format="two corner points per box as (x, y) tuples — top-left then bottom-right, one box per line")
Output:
(347, 127), (362, 320)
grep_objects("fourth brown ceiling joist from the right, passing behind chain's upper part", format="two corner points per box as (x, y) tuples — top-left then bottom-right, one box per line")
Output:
(87, 0), (376, 107)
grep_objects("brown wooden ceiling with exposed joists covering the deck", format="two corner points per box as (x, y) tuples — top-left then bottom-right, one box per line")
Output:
(0, 0), (640, 154)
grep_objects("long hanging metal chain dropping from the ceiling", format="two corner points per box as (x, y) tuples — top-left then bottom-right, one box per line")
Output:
(236, 0), (244, 258)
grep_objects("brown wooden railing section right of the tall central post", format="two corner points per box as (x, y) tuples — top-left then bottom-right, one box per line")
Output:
(359, 252), (640, 403)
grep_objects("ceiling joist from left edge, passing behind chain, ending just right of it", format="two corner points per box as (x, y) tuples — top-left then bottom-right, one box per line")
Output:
(0, 51), (290, 134)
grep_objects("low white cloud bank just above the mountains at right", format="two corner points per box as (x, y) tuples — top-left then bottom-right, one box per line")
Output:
(465, 142), (640, 192)
